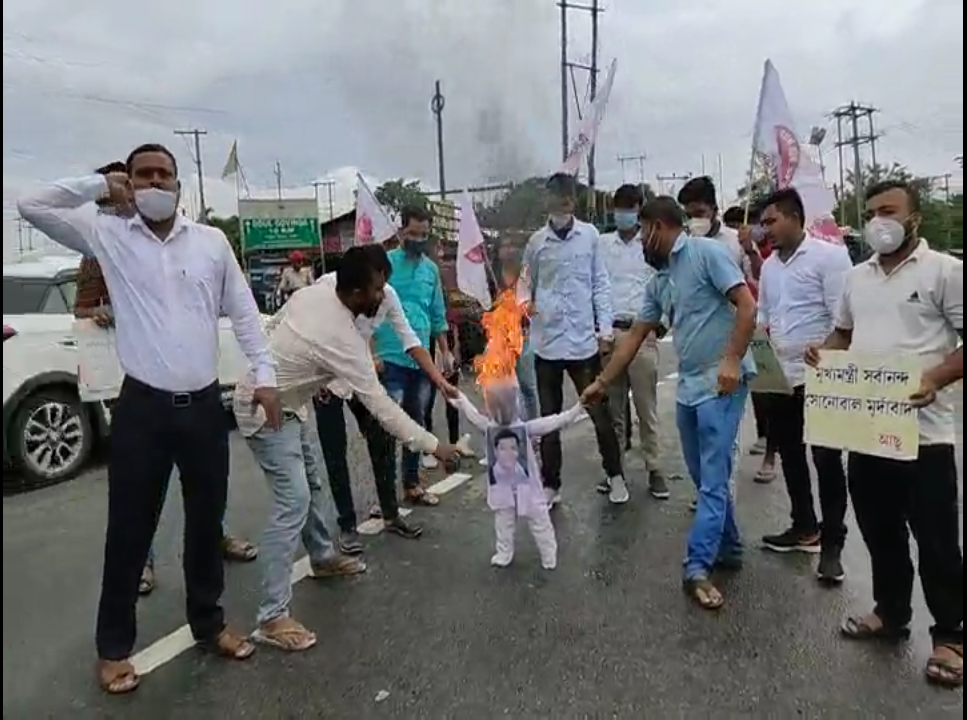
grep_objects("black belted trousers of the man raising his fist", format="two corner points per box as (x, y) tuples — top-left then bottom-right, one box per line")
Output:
(97, 377), (228, 660)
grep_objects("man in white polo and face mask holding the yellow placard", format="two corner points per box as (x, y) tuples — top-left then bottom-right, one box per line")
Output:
(806, 182), (964, 688)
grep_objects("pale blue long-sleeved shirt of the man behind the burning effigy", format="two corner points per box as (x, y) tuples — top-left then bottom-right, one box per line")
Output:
(523, 220), (613, 360)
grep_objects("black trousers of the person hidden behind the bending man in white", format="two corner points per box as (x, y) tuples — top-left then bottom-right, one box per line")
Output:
(314, 396), (400, 533)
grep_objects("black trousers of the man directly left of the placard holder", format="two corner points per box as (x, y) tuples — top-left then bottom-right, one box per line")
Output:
(768, 387), (848, 549)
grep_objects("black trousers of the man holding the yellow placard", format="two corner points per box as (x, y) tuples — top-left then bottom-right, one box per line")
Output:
(848, 445), (964, 645)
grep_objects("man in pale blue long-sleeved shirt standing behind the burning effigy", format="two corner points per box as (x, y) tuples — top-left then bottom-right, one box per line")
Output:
(521, 173), (629, 508)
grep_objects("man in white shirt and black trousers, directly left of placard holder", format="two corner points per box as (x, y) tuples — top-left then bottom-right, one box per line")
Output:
(758, 188), (853, 584)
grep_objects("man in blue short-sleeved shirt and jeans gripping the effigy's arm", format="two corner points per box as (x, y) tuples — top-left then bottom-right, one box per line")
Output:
(582, 197), (756, 610)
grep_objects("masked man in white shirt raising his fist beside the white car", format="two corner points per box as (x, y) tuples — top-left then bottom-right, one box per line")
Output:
(18, 145), (281, 694)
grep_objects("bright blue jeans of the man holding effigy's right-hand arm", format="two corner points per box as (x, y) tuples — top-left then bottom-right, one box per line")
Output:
(677, 385), (749, 580)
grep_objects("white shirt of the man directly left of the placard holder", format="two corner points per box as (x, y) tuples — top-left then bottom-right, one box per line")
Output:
(758, 236), (853, 387)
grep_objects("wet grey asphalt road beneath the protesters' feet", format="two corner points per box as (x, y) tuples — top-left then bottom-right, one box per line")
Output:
(3, 346), (963, 720)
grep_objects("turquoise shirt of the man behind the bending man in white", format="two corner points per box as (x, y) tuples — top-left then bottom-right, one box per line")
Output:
(373, 249), (447, 369)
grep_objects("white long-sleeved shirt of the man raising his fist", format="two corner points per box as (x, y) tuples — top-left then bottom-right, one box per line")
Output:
(18, 175), (275, 392)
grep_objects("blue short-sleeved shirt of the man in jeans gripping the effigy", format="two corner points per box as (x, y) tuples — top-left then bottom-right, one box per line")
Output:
(639, 234), (755, 406)
